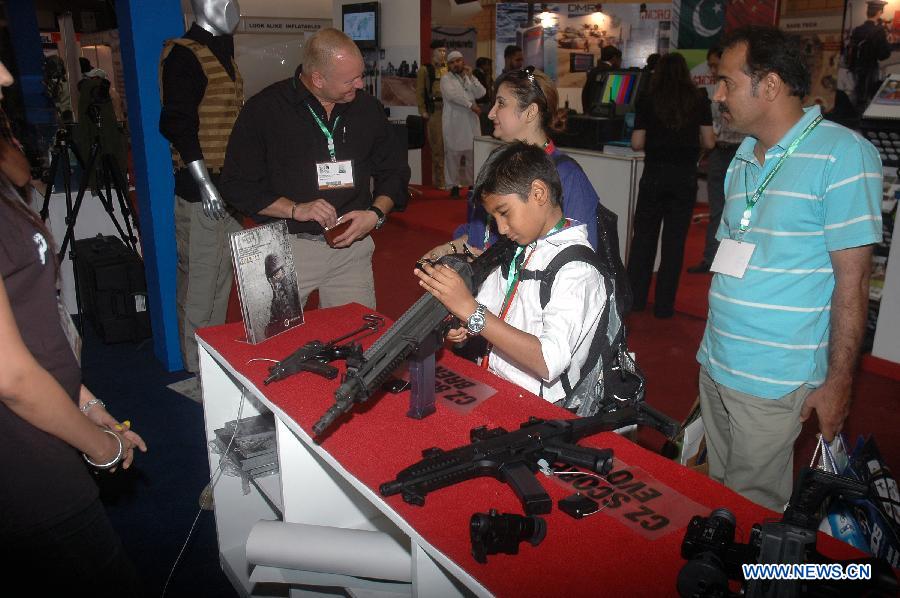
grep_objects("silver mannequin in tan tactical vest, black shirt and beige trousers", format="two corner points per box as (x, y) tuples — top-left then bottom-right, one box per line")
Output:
(159, 0), (244, 373)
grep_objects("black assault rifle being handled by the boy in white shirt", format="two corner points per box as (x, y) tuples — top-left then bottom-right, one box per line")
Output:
(313, 237), (516, 436)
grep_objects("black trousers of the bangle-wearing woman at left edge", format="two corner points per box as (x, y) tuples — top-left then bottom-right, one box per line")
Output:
(0, 500), (141, 598)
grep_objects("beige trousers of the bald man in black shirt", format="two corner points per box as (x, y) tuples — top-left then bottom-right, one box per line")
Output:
(290, 235), (375, 309)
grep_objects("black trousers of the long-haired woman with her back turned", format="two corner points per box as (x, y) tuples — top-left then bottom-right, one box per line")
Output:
(628, 163), (697, 316)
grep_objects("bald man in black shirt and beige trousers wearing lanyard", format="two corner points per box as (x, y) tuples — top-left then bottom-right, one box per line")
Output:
(220, 29), (410, 308)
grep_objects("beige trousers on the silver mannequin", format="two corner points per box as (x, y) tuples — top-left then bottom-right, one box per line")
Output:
(175, 195), (242, 373)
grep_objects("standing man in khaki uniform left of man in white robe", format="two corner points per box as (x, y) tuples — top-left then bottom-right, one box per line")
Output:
(414, 41), (447, 189)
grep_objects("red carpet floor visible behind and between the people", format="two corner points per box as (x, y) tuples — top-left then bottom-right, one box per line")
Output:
(229, 188), (900, 471)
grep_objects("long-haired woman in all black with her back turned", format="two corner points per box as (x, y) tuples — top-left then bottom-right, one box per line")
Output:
(628, 53), (716, 318)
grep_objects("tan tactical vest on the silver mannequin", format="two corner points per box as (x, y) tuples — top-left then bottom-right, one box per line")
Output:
(159, 38), (244, 173)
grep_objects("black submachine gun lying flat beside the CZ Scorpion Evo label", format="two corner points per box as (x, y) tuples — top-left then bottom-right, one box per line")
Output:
(379, 402), (679, 515)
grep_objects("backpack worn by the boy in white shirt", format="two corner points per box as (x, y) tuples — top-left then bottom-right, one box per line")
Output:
(520, 244), (645, 417)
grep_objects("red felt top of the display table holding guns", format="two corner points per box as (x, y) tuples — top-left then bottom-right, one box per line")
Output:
(199, 304), (856, 597)
